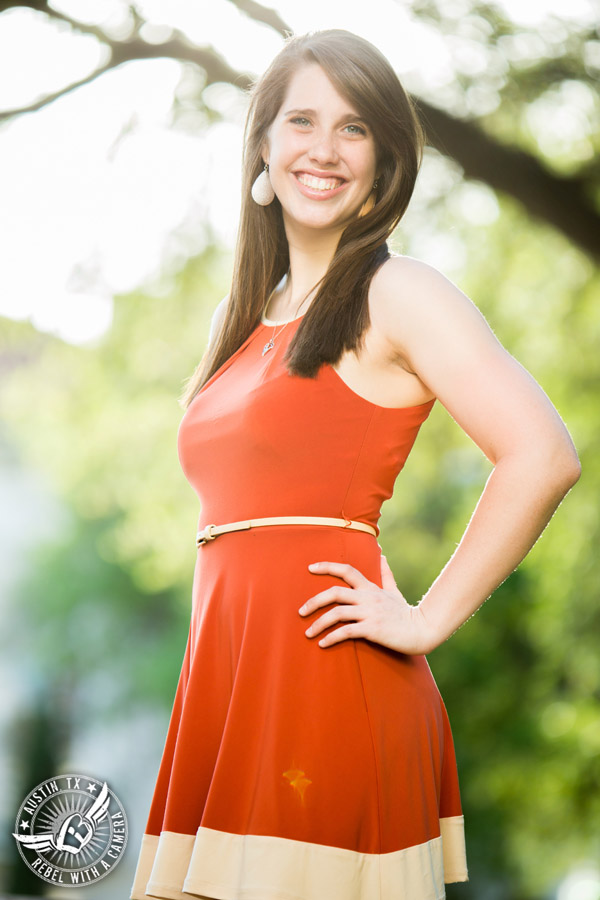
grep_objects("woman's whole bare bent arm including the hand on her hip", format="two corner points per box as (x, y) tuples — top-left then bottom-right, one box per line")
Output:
(299, 257), (581, 654)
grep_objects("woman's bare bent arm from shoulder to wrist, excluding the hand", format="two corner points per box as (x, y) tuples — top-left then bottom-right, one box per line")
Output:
(377, 257), (581, 649)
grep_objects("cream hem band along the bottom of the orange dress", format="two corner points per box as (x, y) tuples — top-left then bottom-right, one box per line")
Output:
(130, 816), (468, 900)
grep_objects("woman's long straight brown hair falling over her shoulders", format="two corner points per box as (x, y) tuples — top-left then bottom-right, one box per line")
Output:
(179, 28), (425, 407)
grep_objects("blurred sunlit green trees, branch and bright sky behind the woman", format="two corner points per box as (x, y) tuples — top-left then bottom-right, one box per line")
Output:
(0, 0), (600, 900)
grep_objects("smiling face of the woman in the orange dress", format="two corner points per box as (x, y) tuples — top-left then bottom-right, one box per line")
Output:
(262, 63), (377, 235)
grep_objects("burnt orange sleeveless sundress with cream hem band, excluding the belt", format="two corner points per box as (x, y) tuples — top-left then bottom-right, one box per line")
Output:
(131, 306), (468, 900)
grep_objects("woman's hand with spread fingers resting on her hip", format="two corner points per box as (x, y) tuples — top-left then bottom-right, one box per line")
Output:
(299, 554), (437, 655)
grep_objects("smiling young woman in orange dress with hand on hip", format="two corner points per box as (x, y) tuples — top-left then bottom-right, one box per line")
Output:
(131, 30), (580, 900)
